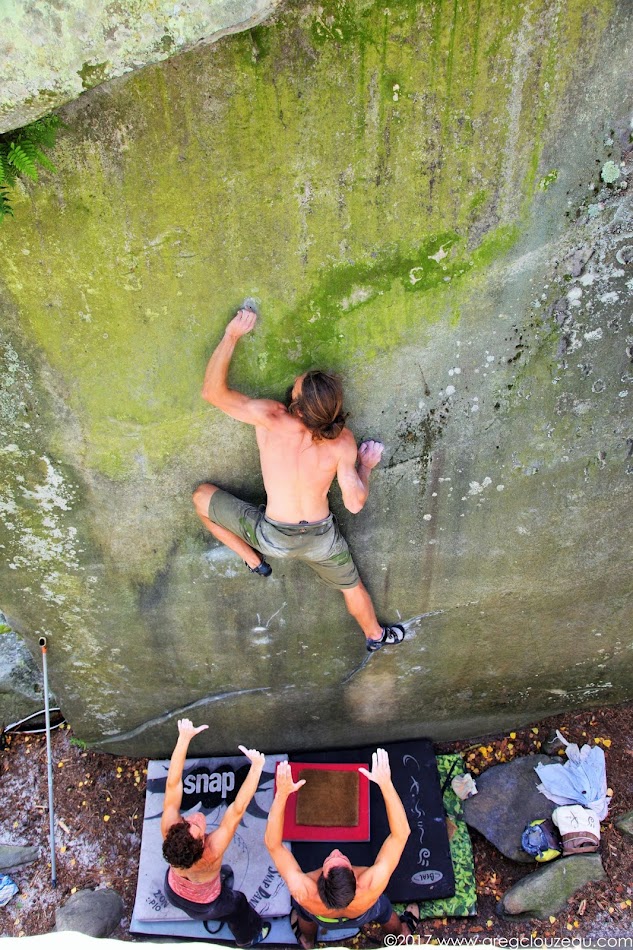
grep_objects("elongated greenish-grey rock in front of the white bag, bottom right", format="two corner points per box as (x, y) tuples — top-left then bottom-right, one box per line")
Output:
(498, 854), (606, 920)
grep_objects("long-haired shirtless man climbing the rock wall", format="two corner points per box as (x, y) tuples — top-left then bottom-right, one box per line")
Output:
(193, 309), (405, 653)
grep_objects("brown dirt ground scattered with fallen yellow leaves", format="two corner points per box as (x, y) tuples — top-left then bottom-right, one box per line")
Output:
(0, 703), (633, 947)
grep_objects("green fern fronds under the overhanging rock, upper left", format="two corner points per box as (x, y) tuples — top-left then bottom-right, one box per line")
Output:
(0, 115), (62, 221)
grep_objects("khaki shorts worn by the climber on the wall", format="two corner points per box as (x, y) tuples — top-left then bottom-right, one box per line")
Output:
(209, 490), (360, 590)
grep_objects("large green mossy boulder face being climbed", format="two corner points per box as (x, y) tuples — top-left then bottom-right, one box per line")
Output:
(0, 0), (633, 755)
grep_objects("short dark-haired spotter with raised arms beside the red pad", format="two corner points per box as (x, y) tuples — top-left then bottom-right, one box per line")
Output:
(264, 749), (419, 950)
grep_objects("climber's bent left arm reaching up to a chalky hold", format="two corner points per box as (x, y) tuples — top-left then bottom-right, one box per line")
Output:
(202, 310), (281, 426)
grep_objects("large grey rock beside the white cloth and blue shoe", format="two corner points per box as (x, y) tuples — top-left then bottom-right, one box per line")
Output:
(463, 755), (559, 864)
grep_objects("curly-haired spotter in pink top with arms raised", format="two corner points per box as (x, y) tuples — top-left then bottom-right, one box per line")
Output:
(160, 719), (270, 947)
